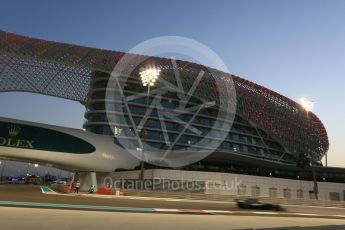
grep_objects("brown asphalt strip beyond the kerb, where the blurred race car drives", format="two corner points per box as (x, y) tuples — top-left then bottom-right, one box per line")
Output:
(0, 185), (345, 216)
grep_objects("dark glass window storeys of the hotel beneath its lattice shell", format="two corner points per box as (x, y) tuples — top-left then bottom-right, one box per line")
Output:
(84, 73), (296, 172)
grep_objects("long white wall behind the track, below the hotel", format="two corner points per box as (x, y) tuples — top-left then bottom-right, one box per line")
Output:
(108, 169), (345, 200)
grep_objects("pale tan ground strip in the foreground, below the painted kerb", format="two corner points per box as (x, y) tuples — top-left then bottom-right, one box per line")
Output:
(0, 207), (345, 230)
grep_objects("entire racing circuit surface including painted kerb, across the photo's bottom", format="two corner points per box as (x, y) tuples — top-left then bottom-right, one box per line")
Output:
(0, 185), (345, 229)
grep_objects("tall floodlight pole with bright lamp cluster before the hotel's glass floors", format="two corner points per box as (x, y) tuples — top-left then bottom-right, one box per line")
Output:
(139, 67), (161, 180)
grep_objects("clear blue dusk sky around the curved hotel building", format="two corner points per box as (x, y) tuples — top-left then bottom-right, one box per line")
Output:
(0, 0), (345, 173)
